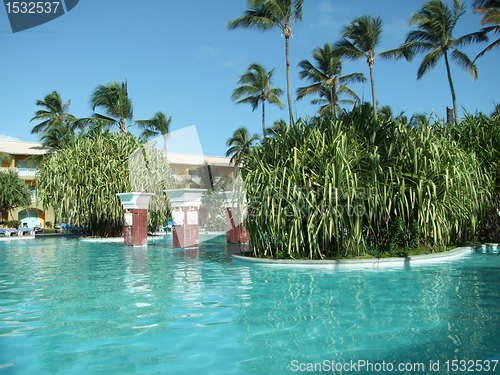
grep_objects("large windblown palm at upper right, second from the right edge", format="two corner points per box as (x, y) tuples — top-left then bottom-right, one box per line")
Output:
(403, 0), (487, 119)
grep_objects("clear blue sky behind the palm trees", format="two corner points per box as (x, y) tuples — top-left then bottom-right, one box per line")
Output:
(0, 0), (500, 156)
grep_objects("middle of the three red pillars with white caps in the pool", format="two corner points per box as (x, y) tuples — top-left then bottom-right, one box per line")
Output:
(165, 189), (206, 248)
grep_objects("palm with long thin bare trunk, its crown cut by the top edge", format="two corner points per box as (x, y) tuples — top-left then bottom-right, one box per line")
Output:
(226, 0), (304, 123)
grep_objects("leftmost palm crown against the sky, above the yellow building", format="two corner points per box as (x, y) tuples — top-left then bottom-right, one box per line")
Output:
(30, 90), (77, 134)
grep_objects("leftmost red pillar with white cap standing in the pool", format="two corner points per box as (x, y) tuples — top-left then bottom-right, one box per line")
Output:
(116, 192), (154, 246)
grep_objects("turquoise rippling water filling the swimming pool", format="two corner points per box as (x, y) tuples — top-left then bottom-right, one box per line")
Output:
(0, 237), (500, 375)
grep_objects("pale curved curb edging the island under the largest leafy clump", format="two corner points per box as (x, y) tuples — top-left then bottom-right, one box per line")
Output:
(232, 244), (498, 269)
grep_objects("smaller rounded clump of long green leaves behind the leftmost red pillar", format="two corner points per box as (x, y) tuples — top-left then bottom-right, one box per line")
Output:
(37, 133), (174, 237)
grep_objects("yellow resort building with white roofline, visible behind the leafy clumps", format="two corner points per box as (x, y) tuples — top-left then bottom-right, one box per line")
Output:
(0, 140), (234, 227)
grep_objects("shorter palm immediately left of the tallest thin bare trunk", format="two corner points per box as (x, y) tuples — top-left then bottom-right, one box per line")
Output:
(231, 63), (285, 142)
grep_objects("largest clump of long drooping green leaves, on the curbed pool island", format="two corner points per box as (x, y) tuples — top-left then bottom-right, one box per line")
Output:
(242, 106), (492, 259)
